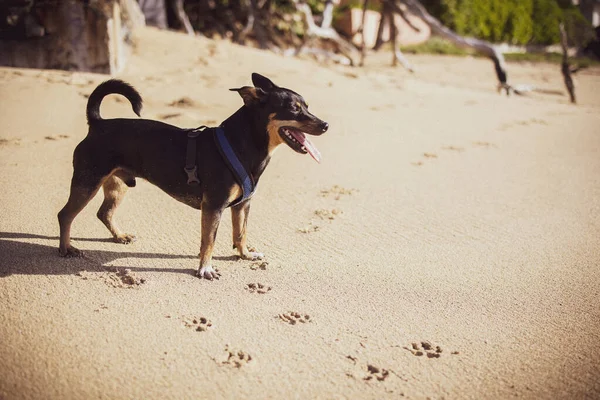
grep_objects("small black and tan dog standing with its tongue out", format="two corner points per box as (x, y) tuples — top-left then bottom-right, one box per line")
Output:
(58, 74), (328, 279)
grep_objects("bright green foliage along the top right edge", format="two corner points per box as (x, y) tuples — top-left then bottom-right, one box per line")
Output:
(423, 0), (589, 45)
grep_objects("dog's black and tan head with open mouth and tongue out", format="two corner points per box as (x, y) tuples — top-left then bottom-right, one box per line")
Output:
(230, 73), (329, 162)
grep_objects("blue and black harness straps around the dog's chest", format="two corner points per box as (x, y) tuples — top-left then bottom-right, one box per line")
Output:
(184, 126), (256, 206)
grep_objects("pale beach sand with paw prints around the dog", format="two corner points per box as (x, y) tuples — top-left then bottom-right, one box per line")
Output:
(0, 29), (600, 399)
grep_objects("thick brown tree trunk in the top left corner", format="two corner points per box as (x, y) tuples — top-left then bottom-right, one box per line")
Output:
(0, 0), (144, 74)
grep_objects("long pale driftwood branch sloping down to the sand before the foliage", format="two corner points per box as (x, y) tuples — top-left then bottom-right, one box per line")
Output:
(399, 0), (511, 94)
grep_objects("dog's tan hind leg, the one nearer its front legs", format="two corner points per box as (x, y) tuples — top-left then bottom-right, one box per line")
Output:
(96, 173), (135, 244)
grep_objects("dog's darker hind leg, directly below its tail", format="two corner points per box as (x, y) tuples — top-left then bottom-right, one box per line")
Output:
(58, 173), (102, 257)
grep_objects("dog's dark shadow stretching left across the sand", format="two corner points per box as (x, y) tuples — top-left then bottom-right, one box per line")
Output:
(0, 232), (237, 278)
